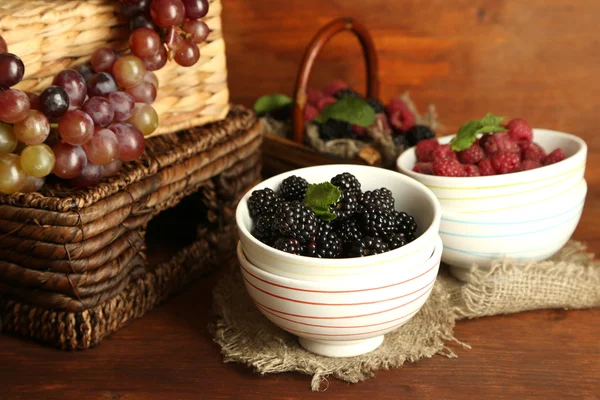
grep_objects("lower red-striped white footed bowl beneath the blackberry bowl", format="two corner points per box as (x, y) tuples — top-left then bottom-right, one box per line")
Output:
(238, 237), (442, 357)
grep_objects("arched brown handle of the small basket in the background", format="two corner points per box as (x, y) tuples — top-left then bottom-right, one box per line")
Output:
(293, 17), (379, 144)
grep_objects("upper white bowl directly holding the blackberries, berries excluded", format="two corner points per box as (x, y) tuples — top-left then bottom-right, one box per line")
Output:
(236, 165), (441, 281)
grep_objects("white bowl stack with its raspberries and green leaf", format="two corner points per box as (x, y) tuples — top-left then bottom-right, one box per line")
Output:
(397, 114), (587, 279)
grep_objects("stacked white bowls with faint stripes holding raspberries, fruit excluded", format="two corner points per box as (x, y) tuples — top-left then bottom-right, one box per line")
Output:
(398, 129), (587, 279)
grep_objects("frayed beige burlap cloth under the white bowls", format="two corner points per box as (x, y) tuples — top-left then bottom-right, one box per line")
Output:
(209, 241), (600, 391)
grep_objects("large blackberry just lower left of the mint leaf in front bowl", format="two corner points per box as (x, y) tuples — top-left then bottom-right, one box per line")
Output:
(273, 201), (318, 245)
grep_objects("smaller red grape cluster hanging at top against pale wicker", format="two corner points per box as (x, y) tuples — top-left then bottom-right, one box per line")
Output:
(120, 0), (210, 71)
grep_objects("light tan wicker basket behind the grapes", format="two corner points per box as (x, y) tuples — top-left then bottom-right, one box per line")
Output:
(0, 0), (229, 136)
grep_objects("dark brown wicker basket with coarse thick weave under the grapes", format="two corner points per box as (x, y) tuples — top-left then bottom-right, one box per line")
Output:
(0, 107), (262, 349)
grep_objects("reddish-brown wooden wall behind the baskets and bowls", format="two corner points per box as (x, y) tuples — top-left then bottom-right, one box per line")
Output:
(223, 0), (600, 183)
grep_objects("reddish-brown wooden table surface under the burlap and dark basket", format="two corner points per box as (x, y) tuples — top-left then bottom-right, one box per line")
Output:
(0, 173), (600, 400)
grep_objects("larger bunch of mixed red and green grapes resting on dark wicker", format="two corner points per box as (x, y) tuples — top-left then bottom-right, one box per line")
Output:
(0, 37), (152, 194)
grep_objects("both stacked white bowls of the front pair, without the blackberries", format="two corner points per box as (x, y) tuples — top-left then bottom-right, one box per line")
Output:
(236, 165), (442, 357)
